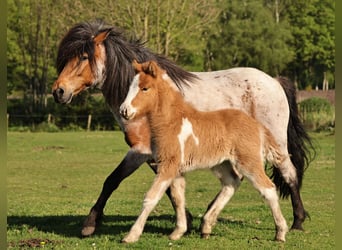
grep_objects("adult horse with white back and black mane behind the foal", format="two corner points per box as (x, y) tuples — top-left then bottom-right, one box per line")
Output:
(52, 21), (312, 236)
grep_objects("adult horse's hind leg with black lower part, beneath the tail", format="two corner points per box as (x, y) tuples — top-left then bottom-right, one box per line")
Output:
(277, 156), (307, 230)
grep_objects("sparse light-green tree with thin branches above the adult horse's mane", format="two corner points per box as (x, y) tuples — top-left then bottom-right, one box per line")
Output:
(89, 0), (223, 70)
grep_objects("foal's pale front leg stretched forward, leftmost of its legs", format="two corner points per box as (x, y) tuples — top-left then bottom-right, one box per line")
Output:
(122, 171), (175, 243)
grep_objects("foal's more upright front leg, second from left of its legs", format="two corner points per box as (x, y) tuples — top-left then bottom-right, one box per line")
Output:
(168, 176), (187, 240)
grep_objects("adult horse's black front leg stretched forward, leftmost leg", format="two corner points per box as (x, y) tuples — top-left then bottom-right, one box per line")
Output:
(82, 149), (151, 236)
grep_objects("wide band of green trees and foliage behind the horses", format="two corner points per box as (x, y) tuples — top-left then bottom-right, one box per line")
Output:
(7, 0), (335, 127)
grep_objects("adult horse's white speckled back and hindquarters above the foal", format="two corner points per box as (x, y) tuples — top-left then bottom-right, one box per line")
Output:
(184, 67), (289, 146)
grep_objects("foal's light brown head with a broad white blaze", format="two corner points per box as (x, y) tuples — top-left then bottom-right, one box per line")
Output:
(120, 61), (166, 120)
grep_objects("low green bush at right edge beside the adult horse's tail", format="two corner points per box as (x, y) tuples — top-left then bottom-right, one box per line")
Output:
(298, 97), (335, 131)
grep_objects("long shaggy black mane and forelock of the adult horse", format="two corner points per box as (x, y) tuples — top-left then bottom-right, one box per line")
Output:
(56, 20), (197, 108)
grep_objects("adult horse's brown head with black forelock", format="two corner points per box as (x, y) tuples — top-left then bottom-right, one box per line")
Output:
(52, 23), (111, 104)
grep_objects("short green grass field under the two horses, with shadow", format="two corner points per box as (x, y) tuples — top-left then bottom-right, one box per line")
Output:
(7, 132), (335, 249)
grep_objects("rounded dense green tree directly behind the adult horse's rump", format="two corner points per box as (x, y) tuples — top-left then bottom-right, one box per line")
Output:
(206, 0), (294, 75)
